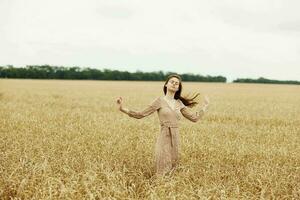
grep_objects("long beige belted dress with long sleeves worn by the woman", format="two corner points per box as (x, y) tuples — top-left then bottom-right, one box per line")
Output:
(128, 96), (201, 175)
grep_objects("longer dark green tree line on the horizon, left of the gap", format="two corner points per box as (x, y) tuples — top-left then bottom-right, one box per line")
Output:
(0, 65), (226, 82)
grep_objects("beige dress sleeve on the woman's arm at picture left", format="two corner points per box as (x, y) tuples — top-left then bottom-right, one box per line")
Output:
(127, 97), (160, 119)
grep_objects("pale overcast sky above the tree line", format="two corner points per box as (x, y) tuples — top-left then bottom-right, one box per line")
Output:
(0, 0), (300, 81)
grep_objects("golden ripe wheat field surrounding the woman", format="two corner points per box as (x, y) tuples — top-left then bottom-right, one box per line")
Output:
(0, 79), (300, 199)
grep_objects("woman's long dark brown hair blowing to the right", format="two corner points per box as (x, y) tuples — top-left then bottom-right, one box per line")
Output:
(163, 74), (200, 107)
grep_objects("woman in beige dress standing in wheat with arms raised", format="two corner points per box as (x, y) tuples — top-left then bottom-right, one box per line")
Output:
(117, 74), (209, 175)
